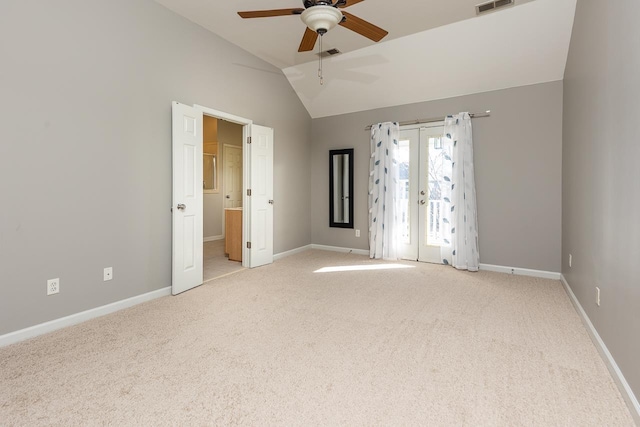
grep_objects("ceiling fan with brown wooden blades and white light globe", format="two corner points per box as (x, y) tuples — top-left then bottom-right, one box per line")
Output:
(238, 0), (389, 52)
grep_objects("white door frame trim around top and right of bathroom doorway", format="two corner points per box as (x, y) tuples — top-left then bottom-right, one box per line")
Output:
(193, 104), (253, 267)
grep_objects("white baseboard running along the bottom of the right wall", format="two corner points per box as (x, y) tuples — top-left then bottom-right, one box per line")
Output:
(560, 274), (640, 426)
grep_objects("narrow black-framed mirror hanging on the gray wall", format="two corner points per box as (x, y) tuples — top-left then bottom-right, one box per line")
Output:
(329, 148), (353, 228)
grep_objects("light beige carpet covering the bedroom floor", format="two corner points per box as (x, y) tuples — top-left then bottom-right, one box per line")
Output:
(0, 251), (633, 426)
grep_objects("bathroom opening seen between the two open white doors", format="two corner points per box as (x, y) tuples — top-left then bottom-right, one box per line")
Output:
(202, 114), (243, 282)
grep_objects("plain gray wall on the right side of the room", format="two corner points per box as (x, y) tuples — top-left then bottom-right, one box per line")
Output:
(562, 0), (640, 402)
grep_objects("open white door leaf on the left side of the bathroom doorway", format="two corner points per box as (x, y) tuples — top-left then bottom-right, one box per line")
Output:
(171, 102), (204, 295)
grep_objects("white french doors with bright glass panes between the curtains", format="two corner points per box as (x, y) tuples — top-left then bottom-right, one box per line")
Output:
(398, 124), (450, 264)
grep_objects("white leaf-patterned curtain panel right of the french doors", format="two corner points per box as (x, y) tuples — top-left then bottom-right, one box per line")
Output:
(440, 113), (480, 271)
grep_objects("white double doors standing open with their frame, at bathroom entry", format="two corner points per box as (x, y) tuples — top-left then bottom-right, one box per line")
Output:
(171, 101), (274, 295)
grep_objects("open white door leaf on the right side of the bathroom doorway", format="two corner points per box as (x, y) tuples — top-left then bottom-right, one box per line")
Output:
(245, 124), (274, 268)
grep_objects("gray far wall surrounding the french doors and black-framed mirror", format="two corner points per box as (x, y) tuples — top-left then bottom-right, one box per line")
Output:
(311, 82), (562, 272)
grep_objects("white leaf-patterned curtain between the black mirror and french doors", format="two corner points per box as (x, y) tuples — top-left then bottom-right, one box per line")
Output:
(369, 122), (400, 260)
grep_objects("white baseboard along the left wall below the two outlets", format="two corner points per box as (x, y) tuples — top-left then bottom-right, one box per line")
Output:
(0, 286), (171, 347)
